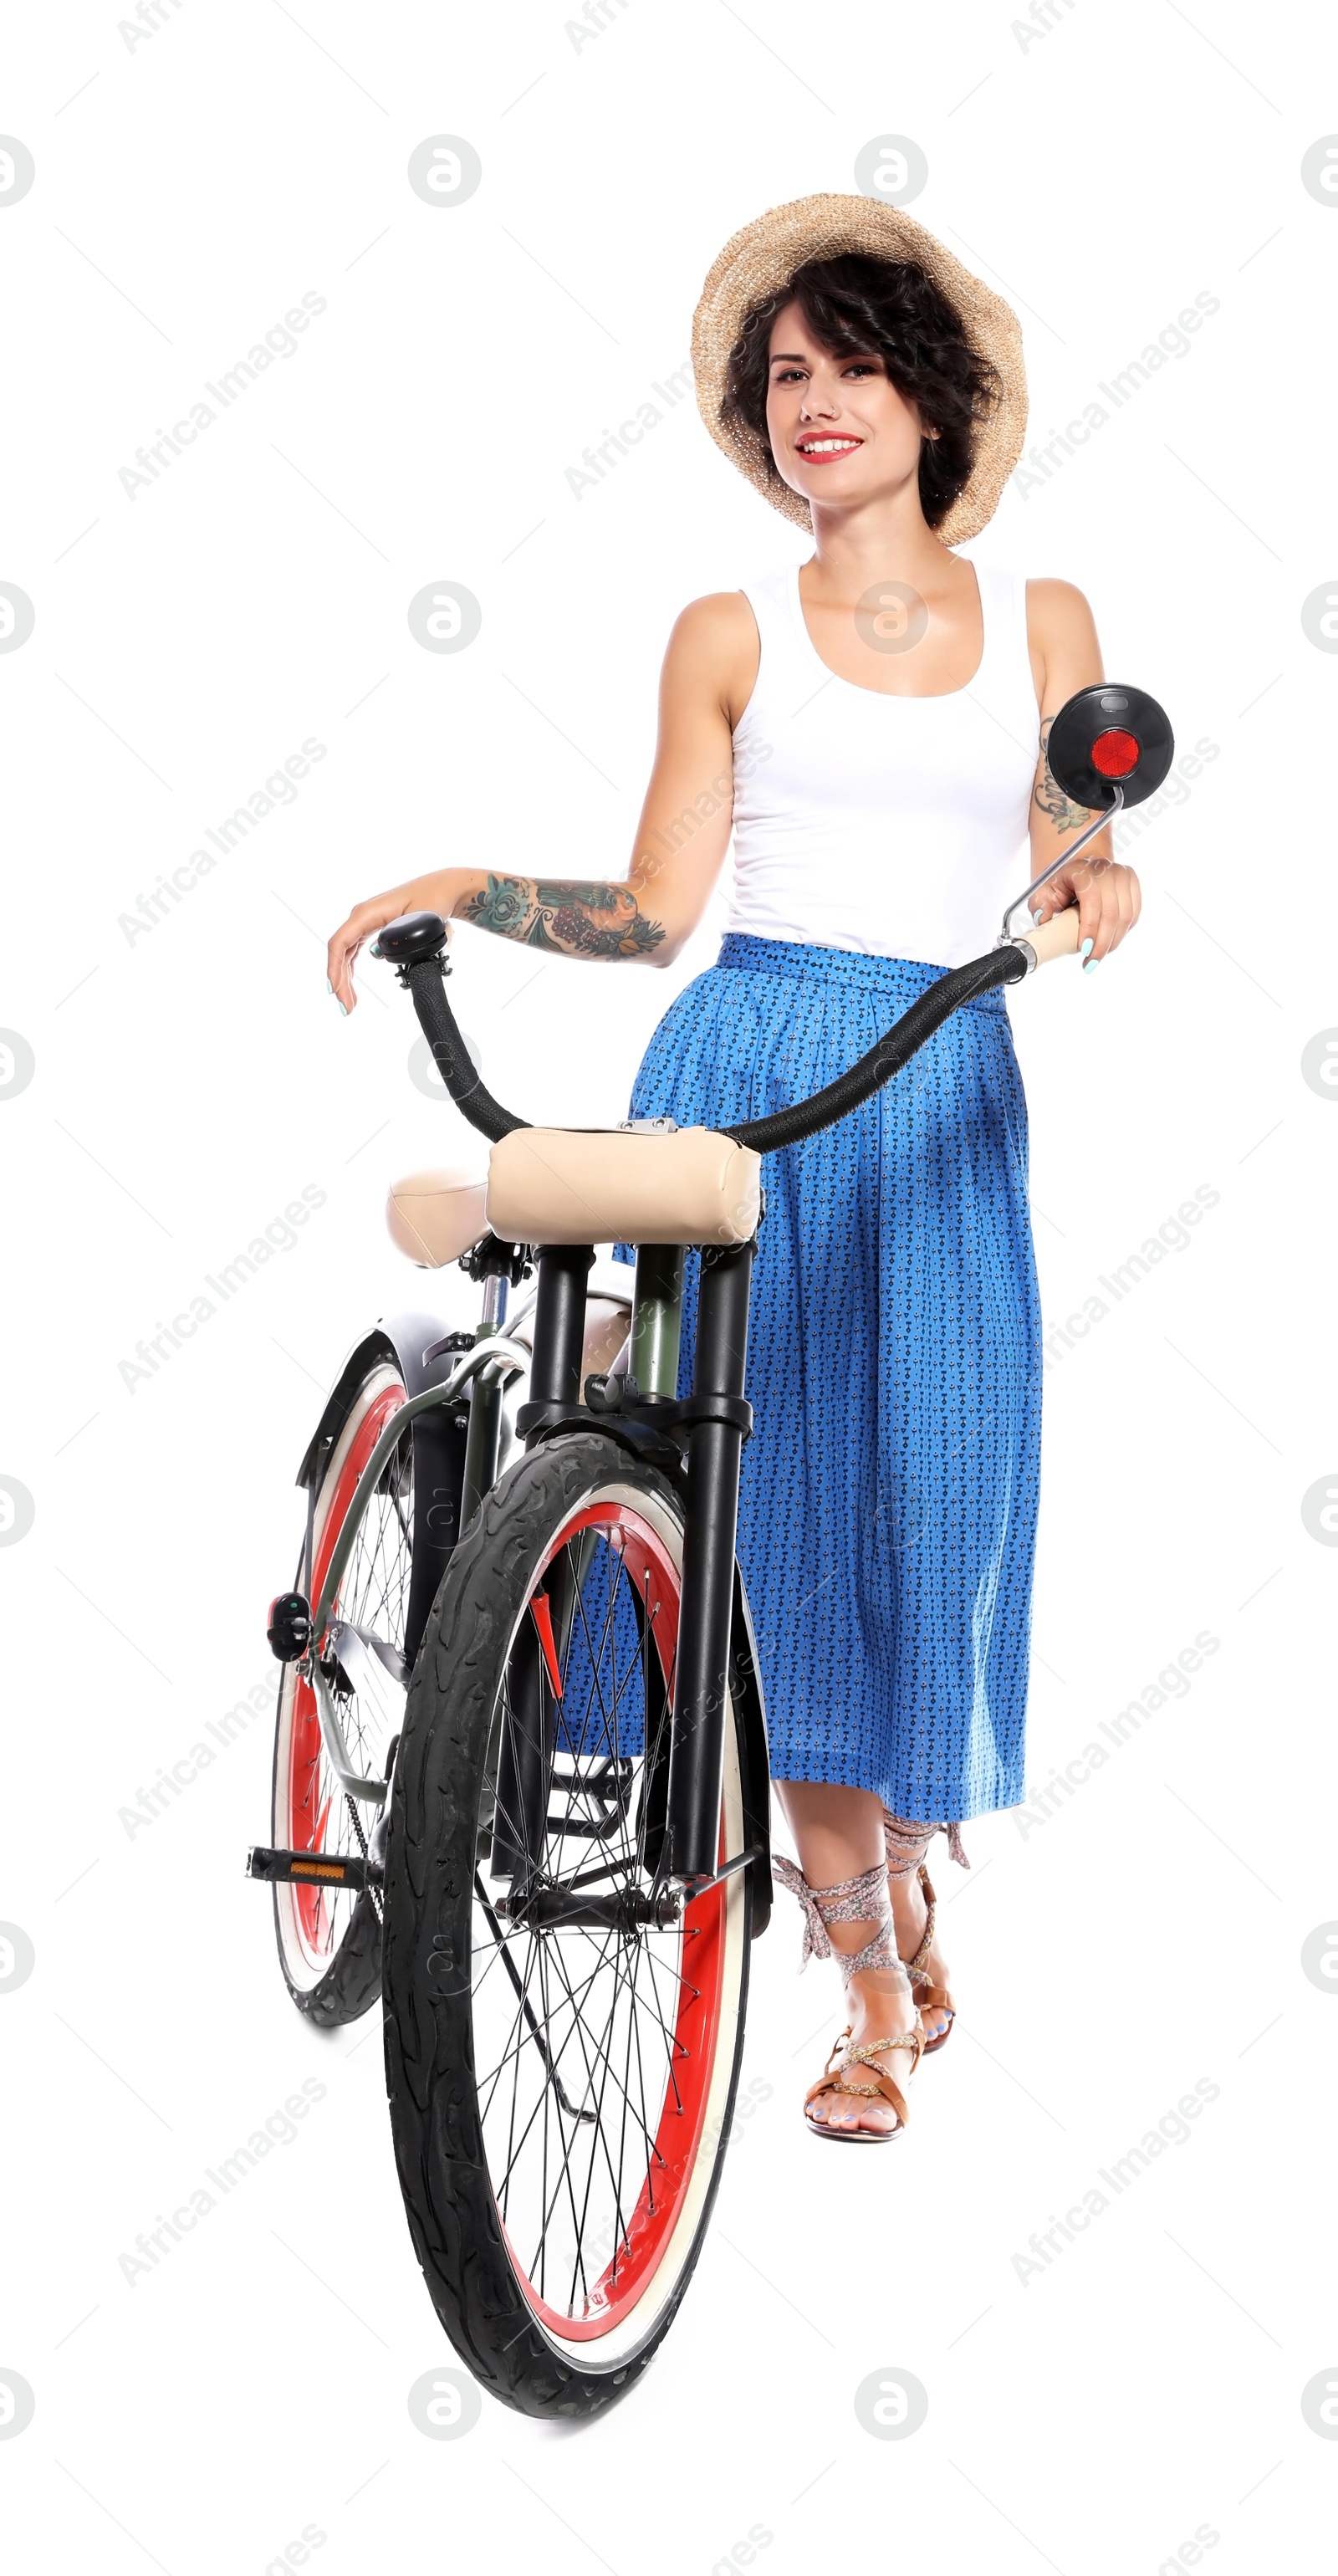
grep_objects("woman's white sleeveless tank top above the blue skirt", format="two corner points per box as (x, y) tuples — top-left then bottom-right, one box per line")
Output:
(724, 565), (1039, 966)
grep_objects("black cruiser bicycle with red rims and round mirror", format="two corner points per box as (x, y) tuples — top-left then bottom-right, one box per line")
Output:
(250, 682), (1173, 2416)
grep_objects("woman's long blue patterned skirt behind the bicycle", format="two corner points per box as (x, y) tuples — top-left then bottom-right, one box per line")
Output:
(621, 933), (1041, 1818)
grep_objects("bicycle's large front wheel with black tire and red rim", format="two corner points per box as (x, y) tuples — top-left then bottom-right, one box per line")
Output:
(384, 1432), (750, 2416)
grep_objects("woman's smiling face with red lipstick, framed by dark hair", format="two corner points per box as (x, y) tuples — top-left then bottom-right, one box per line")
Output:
(766, 304), (933, 508)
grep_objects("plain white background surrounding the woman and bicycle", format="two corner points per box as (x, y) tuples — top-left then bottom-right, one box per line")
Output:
(0, 0), (1338, 2576)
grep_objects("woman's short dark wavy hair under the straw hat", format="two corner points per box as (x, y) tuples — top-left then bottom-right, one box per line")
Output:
(719, 250), (1003, 528)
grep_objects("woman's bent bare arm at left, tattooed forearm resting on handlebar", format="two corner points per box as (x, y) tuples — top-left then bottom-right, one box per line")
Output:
(328, 590), (758, 1009)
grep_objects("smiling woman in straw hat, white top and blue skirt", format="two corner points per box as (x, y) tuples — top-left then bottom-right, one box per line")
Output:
(330, 196), (1140, 2144)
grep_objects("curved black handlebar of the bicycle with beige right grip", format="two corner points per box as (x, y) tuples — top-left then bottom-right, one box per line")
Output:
(371, 912), (1046, 1154)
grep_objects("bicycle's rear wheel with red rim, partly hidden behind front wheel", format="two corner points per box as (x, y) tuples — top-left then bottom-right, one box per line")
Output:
(273, 1357), (412, 2025)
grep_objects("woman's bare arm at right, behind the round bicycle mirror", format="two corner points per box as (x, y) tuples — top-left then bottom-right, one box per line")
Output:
(1026, 582), (1142, 963)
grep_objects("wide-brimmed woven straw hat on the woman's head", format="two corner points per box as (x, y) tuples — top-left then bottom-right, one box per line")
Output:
(693, 196), (1026, 546)
